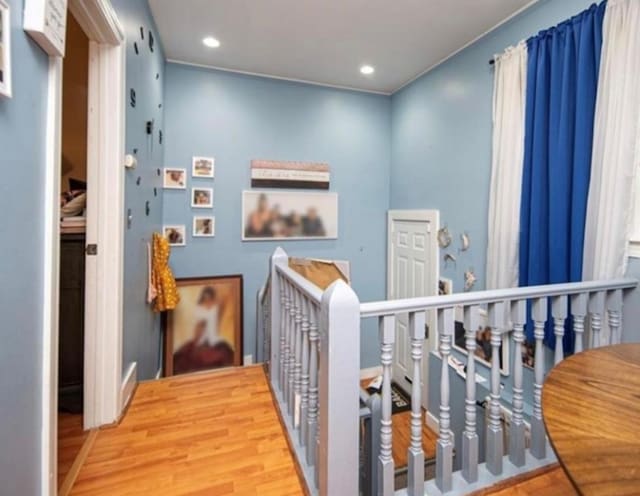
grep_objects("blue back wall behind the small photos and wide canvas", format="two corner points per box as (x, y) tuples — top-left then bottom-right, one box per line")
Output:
(164, 64), (391, 366)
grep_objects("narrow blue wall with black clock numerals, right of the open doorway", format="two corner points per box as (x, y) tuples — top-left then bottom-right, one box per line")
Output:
(112, 0), (165, 379)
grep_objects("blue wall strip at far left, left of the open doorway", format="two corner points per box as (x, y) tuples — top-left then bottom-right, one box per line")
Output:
(0, 0), (49, 496)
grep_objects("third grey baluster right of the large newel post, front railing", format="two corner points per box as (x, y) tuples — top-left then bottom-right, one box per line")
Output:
(436, 308), (455, 493)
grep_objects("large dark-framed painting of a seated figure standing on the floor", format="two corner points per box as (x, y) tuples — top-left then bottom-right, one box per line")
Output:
(164, 275), (242, 376)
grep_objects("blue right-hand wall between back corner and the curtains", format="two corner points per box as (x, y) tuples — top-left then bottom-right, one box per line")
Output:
(390, 0), (592, 292)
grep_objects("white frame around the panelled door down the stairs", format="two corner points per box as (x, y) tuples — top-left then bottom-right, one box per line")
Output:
(387, 210), (440, 410)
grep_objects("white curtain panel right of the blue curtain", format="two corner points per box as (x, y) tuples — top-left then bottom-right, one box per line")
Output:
(582, 0), (640, 280)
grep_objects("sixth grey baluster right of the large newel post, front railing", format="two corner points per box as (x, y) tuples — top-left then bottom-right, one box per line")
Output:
(509, 300), (527, 467)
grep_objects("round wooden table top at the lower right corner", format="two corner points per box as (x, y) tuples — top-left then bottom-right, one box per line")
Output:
(542, 344), (640, 496)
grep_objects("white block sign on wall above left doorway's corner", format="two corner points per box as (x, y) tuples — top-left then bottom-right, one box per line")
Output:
(24, 0), (67, 57)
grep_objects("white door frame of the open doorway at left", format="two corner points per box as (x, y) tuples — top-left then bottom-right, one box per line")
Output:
(41, 0), (126, 496)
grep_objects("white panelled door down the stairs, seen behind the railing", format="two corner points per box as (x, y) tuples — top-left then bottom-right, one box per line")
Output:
(387, 210), (438, 406)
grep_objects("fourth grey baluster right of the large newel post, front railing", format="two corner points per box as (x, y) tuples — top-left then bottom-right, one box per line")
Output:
(462, 306), (480, 483)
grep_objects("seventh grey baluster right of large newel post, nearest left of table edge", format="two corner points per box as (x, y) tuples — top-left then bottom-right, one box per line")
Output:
(531, 298), (548, 459)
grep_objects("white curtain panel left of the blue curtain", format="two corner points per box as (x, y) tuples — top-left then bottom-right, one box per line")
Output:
(486, 42), (527, 289)
